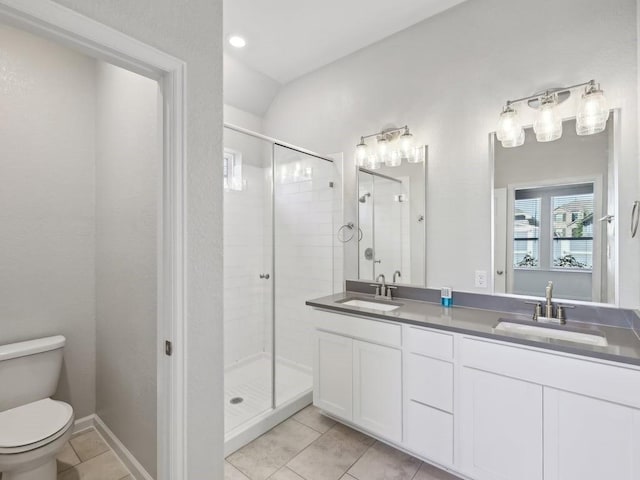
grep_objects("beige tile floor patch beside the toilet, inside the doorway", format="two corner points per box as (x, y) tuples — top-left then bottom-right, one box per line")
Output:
(57, 428), (133, 480)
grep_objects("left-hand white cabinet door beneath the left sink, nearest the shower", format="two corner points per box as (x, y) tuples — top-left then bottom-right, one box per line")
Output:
(313, 332), (353, 421)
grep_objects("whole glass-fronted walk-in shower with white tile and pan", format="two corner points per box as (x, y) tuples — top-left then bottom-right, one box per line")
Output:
(224, 125), (341, 453)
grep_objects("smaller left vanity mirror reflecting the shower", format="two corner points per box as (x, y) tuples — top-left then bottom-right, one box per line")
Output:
(357, 146), (427, 286)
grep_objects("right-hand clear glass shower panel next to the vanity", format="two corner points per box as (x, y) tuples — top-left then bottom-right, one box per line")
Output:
(273, 144), (336, 406)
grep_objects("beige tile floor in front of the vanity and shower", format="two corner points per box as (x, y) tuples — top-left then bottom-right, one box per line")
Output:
(224, 405), (459, 480)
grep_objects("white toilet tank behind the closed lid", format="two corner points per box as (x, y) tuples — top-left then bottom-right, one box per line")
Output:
(0, 335), (65, 412)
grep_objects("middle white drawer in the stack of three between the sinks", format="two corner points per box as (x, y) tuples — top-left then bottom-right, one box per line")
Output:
(407, 353), (453, 413)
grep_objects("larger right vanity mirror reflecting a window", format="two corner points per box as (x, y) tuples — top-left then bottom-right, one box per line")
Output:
(492, 115), (617, 303)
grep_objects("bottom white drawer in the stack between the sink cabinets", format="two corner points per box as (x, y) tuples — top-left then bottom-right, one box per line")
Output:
(406, 402), (453, 466)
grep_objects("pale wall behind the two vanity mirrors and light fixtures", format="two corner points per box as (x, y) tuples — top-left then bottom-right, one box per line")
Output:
(265, 0), (640, 306)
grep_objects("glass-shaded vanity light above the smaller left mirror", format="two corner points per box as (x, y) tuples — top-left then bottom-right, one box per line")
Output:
(356, 125), (424, 170)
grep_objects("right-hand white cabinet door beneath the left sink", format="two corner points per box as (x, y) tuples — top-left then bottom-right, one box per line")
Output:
(353, 340), (402, 442)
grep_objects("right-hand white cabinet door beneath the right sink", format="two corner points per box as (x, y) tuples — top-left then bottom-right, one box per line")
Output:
(544, 388), (640, 480)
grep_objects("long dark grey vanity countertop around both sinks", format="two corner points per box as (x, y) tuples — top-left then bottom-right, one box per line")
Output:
(306, 292), (640, 366)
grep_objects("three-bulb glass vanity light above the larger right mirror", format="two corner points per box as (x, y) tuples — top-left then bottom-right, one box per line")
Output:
(496, 80), (609, 148)
